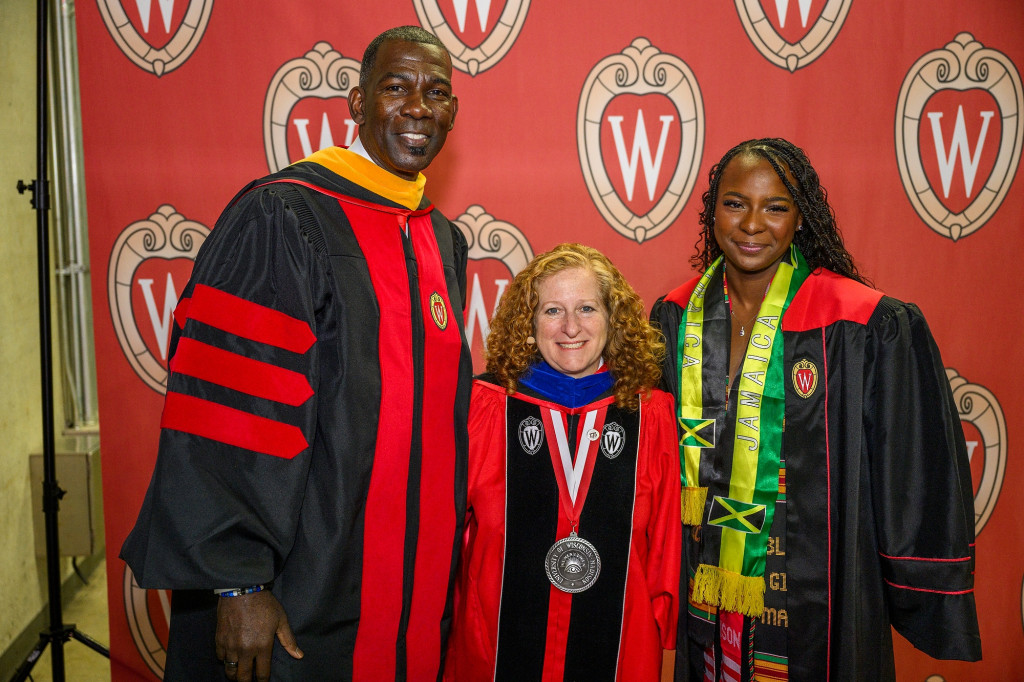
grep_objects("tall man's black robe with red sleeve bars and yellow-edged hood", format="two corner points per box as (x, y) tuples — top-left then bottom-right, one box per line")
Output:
(122, 147), (471, 681)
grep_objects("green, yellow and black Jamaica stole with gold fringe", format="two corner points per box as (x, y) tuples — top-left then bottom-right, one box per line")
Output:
(677, 245), (810, 615)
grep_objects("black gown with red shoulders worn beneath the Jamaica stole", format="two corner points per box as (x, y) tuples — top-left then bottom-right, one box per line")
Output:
(651, 269), (981, 682)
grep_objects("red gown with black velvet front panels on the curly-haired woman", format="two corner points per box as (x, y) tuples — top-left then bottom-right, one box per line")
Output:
(444, 377), (681, 682)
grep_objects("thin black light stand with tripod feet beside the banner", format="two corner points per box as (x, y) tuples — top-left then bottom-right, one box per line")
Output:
(11, 0), (111, 682)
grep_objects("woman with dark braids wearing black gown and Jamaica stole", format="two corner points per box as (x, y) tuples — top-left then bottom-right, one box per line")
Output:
(651, 138), (981, 682)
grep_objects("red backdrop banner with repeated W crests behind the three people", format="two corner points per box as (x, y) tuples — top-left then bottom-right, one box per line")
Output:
(76, 0), (1024, 682)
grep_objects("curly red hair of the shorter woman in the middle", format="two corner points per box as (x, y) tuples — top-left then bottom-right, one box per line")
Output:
(485, 244), (665, 410)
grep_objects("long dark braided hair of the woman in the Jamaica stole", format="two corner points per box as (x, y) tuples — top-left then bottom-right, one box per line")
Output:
(690, 137), (870, 286)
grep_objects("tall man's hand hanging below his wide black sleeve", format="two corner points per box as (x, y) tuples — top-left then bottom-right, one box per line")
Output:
(216, 590), (303, 682)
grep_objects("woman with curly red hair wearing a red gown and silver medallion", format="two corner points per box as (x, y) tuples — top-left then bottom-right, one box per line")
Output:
(445, 244), (681, 680)
